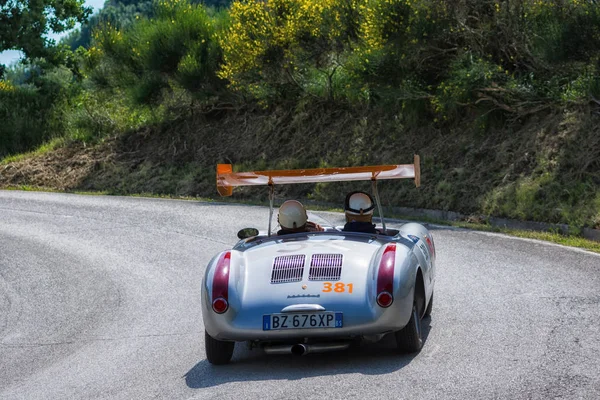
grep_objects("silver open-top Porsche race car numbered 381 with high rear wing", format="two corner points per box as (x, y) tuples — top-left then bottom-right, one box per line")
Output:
(202, 156), (436, 364)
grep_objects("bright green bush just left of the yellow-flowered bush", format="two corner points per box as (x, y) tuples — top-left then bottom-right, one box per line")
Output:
(87, 0), (221, 103)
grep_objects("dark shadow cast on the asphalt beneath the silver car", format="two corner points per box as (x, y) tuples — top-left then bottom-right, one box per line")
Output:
(185, 318), (431, 389)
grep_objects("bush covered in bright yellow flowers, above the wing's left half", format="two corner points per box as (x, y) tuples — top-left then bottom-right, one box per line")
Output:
(219, 0), (359, 101)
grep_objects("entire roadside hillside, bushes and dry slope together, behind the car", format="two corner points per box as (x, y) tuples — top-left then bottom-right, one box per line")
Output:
(0, 0), (600, 231)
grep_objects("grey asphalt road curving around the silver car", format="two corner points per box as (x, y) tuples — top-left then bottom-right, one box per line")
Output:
(0, 191), (600, 400)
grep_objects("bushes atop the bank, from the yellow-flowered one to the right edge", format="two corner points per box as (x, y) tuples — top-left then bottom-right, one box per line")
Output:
(220, 0), (600, 115)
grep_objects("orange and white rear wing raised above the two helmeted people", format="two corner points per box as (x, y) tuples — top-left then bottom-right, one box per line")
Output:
(217, 155), (421, 196)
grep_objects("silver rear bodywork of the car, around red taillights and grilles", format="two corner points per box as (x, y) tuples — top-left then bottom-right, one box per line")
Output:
(202, 223), (435, 341)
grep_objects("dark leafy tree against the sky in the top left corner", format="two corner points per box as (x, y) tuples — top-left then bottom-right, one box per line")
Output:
(0, 0), (91, 59)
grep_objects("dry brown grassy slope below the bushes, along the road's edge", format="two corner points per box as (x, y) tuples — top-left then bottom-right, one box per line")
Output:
(0, 101), (600, 231)
